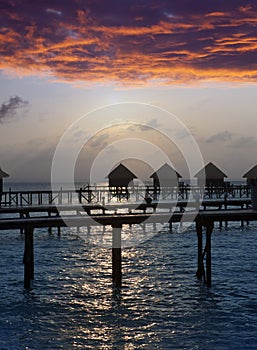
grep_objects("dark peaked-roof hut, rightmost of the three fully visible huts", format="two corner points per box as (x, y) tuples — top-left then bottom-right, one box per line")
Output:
(195, 162), (227, 187)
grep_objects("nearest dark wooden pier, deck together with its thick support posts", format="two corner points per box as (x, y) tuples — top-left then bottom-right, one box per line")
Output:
(0, 206), (257, 289)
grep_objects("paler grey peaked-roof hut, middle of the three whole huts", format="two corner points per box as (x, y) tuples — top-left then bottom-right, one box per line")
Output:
(150, 163), (182, 187)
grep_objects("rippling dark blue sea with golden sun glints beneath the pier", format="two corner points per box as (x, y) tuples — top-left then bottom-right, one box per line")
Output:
(0, 184), (257, 350)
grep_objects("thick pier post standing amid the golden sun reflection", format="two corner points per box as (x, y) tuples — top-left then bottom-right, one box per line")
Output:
(112, 225), (122, 288)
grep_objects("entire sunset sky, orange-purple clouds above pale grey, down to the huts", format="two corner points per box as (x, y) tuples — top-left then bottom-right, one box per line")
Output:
(0, 0), (257, 182)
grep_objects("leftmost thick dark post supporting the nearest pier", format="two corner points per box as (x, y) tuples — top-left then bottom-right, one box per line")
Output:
(23, 227), (34, 289)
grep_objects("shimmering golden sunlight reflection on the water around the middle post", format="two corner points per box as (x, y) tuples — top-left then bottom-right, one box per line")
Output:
(50, 242), (163, 349)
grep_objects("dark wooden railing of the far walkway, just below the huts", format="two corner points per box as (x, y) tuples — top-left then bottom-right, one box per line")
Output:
(0, 185), (251, 206)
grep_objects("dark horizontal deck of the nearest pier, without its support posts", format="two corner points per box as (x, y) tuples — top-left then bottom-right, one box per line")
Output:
(0, 207), (257, 230)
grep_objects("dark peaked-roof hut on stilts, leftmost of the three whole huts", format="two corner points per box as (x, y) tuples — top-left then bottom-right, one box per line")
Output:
(107, 163), (137, 199)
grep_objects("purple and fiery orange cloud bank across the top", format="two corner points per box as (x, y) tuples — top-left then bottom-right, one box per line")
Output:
(0, 0), (257, 85)
